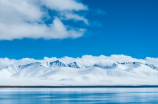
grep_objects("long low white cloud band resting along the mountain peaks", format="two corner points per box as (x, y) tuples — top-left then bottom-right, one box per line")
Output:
(0, 55), (158, 69)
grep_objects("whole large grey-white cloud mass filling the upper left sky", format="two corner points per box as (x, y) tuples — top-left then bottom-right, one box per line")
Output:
(0, 0), (88, 40)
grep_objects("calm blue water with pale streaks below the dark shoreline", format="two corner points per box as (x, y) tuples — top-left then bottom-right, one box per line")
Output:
(0, 87), (158, 104)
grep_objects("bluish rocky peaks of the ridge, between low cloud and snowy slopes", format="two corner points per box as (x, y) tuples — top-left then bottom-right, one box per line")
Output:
(0, 60), (158, 70)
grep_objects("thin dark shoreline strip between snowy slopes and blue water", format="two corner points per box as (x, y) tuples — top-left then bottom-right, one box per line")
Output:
(0, 85), (158, 88)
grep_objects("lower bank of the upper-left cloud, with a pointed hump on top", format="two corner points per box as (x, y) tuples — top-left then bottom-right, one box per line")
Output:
(0, 18), (85, 40)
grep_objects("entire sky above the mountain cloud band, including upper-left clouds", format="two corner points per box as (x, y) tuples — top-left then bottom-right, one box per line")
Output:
(0, 0), (158, 59)
